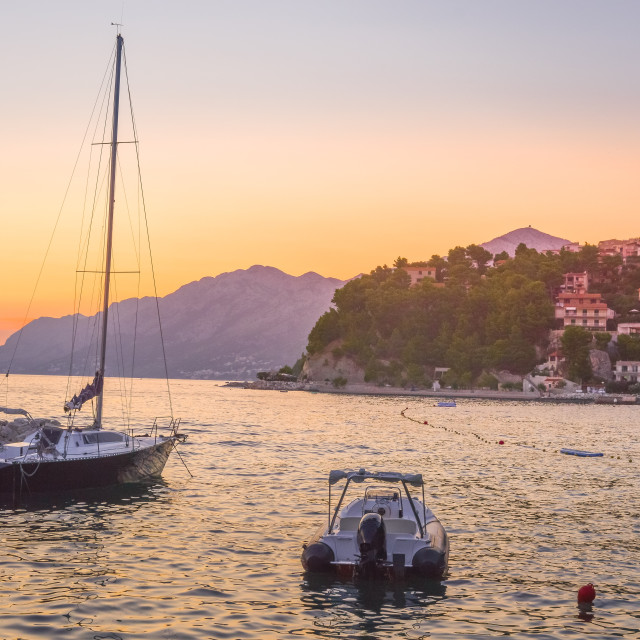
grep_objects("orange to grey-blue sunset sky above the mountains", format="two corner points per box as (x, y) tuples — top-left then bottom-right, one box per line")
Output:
(0, 0), (640, 344)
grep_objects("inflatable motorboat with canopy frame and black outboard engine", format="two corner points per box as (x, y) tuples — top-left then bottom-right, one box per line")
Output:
(301, 469), (449, 580)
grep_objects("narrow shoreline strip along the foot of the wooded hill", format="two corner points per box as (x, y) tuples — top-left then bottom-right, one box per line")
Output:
(222, 380), (639, 405)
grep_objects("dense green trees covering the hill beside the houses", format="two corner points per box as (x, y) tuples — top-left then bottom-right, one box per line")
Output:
(307, 245), (640, 386)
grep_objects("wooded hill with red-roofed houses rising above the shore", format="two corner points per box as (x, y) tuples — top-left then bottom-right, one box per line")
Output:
(268, 229), (640, 402)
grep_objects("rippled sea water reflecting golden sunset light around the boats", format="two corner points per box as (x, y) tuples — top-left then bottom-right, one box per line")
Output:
(0, 376), (640, 640)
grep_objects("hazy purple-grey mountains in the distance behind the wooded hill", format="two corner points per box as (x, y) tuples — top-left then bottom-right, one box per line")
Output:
(0, 227), (569, 380)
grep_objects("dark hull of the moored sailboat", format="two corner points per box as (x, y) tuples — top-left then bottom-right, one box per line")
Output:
(0, 438), (174, 496)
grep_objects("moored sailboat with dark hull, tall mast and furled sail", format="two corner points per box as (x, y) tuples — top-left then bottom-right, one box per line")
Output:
(0, 33), (185, 499)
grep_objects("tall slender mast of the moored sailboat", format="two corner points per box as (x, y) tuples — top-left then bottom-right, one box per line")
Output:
(95, 34), (124, 429)
